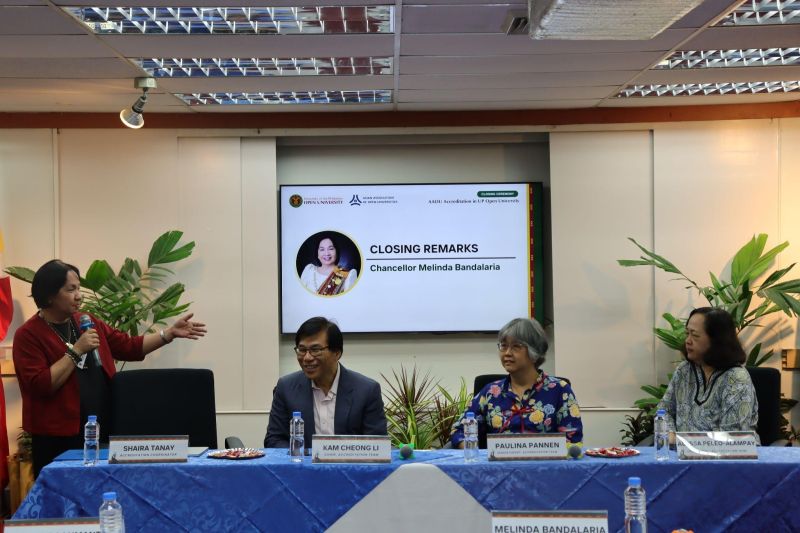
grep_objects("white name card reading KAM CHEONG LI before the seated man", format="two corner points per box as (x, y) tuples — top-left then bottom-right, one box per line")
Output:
(311, 435), (392, 463)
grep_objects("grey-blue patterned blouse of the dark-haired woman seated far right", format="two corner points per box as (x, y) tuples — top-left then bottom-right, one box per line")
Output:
(658, 361), (758, 431)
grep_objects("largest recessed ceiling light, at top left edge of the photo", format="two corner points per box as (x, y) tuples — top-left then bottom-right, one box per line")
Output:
(62, 6), (394, 35)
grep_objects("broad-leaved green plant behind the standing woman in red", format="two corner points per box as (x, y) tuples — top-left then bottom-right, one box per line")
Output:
(5, 231), (195, 335)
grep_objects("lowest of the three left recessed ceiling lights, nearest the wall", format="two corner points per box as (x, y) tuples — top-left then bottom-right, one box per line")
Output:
(180, 90), (392, 106)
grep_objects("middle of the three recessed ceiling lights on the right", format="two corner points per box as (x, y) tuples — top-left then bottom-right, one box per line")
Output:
(653, 48), (800, 70)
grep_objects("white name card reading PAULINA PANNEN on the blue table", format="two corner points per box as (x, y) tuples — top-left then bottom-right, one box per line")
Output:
(486, 433), (567, 461)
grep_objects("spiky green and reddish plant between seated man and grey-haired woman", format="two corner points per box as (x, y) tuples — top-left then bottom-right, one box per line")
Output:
(381, 366), (472, 450)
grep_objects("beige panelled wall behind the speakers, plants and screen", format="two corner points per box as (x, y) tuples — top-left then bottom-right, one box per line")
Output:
(0, 119), (800, 445)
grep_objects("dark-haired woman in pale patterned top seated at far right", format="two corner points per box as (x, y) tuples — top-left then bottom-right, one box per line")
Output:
(658, 307), (758, 441)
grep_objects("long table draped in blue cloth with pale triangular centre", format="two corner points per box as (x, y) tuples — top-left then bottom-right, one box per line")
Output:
(14, 448), (800, 533)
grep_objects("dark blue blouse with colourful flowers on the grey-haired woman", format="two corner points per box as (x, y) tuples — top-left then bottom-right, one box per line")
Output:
(450, 372), (583, 447)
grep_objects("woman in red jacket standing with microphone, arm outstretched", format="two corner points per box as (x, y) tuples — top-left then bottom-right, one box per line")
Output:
(13, 259), (206, 476)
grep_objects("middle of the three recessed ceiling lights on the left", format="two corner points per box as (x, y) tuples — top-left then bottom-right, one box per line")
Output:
(132, 57), (392, 78)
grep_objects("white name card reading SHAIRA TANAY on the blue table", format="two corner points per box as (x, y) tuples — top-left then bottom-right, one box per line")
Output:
(108, 435), (189, 464)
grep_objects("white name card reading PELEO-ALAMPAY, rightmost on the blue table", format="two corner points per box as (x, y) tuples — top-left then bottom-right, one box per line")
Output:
(675, 431), (758, 461)
